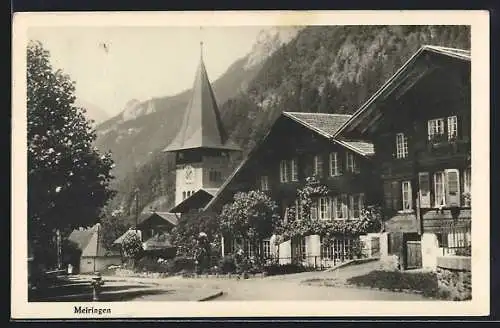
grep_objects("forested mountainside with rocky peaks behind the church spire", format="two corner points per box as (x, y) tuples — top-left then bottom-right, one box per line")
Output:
(98, 26), (470, 218)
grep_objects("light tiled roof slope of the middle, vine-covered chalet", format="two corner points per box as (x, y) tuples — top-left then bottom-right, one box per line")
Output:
(283, 112), (374, 156)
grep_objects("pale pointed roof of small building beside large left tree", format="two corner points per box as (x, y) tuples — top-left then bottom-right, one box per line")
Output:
(68, 223), (118, 257)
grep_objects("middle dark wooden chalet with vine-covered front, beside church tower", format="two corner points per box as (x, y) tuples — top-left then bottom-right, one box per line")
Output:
(204, 112), (380, 265)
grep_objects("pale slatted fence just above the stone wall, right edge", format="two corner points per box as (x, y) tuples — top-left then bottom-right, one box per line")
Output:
(438, 220), (471, 256)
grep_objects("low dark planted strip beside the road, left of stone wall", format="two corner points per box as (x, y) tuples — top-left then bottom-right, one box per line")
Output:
(347, 270), (438, 297)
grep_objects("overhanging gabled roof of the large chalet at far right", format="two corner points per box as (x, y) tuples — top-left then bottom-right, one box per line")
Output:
(334, 45), (471, 138)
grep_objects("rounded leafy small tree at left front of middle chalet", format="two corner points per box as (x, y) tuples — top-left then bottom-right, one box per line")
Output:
(219, 191), (280, 256)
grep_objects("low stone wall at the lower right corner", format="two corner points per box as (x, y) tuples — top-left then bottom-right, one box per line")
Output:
(436, 256), (472, 301)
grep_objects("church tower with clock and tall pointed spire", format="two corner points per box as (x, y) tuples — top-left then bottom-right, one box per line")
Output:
(164, 43), (240, 205)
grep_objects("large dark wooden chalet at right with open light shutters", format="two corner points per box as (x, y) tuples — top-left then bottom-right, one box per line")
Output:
(334, 46), (472, 269)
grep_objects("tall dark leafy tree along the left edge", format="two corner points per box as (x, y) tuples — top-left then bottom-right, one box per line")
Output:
(27, 41), (113, 264)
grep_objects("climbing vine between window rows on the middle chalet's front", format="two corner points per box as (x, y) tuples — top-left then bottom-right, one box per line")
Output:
(276, 177), (382, 245)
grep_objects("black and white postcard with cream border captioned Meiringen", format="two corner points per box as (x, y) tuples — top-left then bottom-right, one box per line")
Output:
(12, 12), (489, 318)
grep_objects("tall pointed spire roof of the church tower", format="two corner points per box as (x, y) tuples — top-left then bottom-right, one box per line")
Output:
(164, 50), (239, 152)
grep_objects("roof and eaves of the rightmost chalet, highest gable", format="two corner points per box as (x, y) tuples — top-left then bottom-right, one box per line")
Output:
(334, 45), (471, 139)
